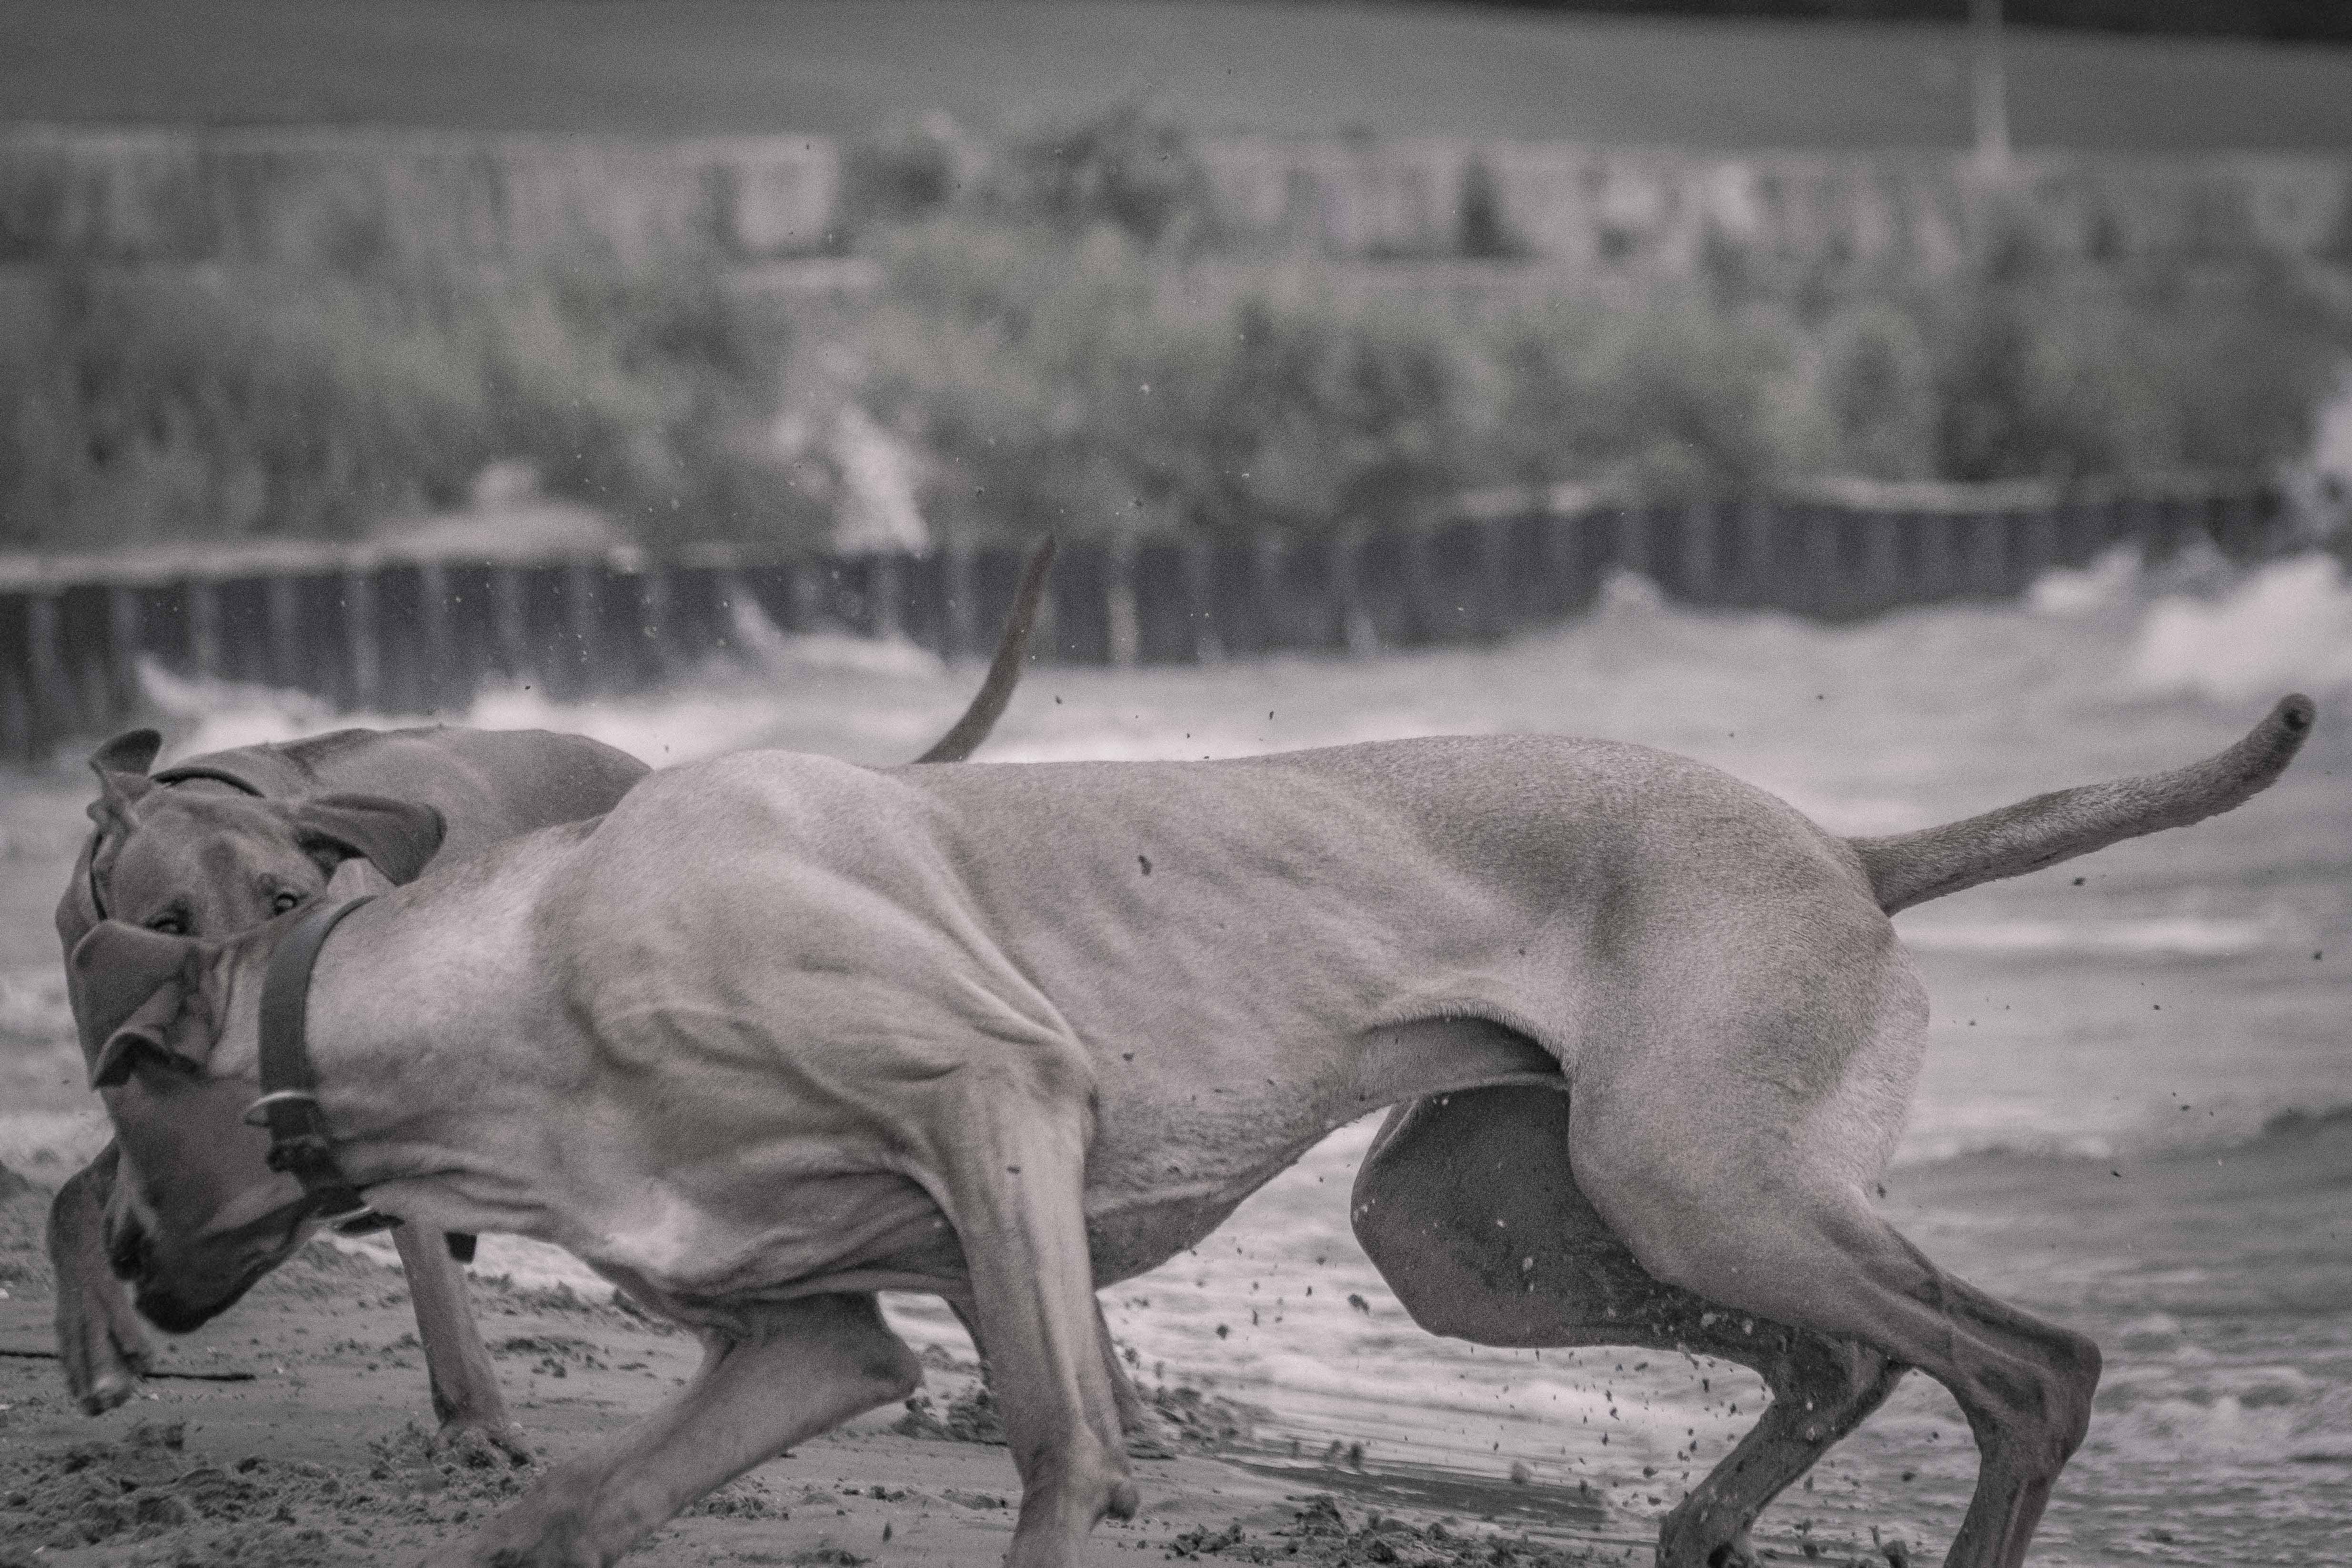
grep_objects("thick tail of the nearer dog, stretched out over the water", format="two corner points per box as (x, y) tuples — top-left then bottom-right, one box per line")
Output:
(1846, 696), (2317, 915)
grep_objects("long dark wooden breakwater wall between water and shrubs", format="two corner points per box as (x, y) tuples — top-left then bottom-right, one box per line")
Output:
(0, 493), (2291, 762)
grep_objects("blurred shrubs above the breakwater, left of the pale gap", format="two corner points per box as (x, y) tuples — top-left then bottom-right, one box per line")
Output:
(0, 255), (821, 548)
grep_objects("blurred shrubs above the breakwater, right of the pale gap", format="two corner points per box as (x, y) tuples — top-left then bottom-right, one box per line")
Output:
(865, 207), (2352, 533)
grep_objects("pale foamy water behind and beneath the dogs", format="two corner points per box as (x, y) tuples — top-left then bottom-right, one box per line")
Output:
(0, 555), (2352, 1563)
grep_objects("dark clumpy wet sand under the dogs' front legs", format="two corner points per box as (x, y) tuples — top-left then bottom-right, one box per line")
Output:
(0, 1176), (1635, 1568)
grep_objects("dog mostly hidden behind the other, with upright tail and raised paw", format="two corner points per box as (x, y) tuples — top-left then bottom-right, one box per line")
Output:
(47, 543), (1054, 1457)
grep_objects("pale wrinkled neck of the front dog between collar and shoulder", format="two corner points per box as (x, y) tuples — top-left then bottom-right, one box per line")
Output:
(272, 830), (588, 1239)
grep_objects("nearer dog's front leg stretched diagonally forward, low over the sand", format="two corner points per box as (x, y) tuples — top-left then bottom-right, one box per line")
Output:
(433, 1295), (922, 1568)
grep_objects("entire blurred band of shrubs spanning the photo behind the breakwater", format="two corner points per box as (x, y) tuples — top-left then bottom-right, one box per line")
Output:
(14, 106), (2352, 550)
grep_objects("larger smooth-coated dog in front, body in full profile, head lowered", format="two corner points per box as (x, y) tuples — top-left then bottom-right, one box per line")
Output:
(73, 698), (2312, 1568)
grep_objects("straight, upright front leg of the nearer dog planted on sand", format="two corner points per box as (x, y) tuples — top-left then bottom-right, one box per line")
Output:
(941, 1100), (1136, 1568)
